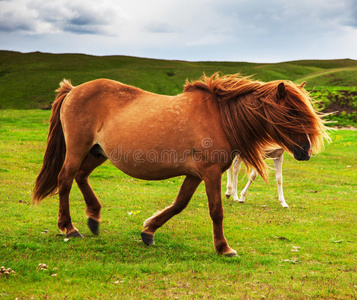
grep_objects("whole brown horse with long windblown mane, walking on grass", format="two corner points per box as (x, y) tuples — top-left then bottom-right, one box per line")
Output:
(33, 73), (328, 256)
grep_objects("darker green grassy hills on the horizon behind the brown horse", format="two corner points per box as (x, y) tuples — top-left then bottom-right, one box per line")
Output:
(0, 51), (357, 126)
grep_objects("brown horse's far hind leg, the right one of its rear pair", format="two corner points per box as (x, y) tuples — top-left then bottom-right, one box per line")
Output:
(75, 153), (107, 235)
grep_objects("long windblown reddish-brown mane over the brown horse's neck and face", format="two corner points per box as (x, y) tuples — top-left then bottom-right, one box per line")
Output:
(184, 73), (329, 180)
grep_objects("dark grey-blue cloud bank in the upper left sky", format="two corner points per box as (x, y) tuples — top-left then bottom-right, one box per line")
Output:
(0, 0), (116, 34)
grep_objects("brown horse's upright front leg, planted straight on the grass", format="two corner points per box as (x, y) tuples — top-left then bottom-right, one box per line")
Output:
(203, 170), (237, 256)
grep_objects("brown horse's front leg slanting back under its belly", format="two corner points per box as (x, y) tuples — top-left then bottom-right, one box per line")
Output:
(141, 176), (202, 245)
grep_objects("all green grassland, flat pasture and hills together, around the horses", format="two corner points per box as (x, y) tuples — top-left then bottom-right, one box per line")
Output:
(0, 51), (357, 299)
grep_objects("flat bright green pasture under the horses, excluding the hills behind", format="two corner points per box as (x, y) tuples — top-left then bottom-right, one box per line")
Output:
(0, 110), (357, 299)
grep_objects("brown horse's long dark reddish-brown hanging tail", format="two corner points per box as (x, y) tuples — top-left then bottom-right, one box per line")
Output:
(32, 79), (73, 203)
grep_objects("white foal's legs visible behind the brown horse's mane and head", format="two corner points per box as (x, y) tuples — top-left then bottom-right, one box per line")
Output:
(226, 149), (289, 208)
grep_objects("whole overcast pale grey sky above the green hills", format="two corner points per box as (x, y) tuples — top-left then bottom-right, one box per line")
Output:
(0, 0), (357, 62)
